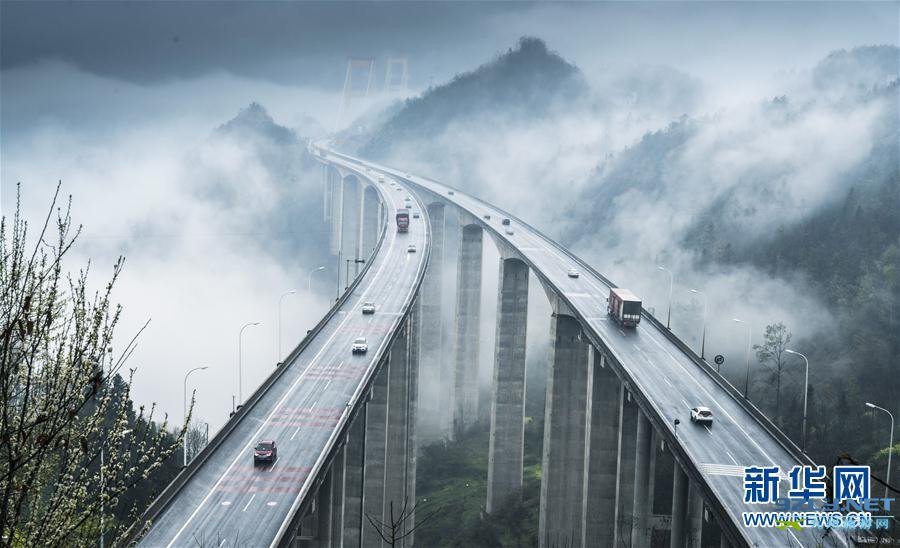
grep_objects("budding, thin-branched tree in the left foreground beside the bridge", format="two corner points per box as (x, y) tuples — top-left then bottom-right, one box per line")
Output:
(0, 186), (184, 546)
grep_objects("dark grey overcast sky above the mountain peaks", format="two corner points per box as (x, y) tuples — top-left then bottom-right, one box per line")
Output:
(0, 2), (898, 91)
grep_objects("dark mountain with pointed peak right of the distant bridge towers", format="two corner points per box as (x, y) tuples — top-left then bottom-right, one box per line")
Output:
(359, 37), (588, 158)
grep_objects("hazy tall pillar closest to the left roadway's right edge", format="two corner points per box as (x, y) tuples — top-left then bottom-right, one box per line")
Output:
(418, 204), (453, 445)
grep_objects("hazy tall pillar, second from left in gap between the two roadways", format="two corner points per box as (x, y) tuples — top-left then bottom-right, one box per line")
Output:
(453, 224), (483, 434)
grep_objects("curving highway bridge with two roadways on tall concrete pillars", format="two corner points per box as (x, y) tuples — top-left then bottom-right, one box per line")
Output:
(129, 145), (852, 547)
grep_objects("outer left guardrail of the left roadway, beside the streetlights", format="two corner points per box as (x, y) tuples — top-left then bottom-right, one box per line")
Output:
(121, 166), (390, 545)
